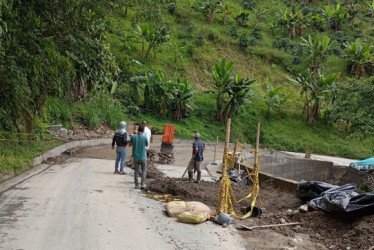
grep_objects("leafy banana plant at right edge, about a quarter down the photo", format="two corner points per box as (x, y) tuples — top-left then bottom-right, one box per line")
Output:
(344, 38), (374, 78)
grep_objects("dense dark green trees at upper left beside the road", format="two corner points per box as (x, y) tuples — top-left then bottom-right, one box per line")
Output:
(0, 0), (119, 133)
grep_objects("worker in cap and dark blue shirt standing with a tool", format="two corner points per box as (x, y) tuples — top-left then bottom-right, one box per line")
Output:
(188, 133), (205, 183)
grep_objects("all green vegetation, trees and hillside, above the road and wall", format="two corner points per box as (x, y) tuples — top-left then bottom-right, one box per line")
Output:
(0, 0), (374, 178)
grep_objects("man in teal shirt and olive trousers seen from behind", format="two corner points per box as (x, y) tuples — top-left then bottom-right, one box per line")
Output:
(129, 126), (148, 189)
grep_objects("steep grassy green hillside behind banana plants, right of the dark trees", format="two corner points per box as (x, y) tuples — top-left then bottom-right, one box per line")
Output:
(108, 0), (374, 158)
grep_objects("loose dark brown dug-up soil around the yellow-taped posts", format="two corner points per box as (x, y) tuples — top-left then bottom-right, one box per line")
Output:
(148, 177), (374, 250)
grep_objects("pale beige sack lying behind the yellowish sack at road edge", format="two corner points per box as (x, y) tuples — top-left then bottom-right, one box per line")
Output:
(165, 201), (212, 219)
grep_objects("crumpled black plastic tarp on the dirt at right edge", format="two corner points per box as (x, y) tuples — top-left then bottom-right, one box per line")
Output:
(298, 181), (374, 213)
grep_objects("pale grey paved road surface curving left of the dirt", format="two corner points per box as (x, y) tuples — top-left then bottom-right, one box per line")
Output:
(0, 158), (248, 250)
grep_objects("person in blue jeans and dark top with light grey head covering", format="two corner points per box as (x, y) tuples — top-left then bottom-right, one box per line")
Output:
(112, 121), (128, 175)
